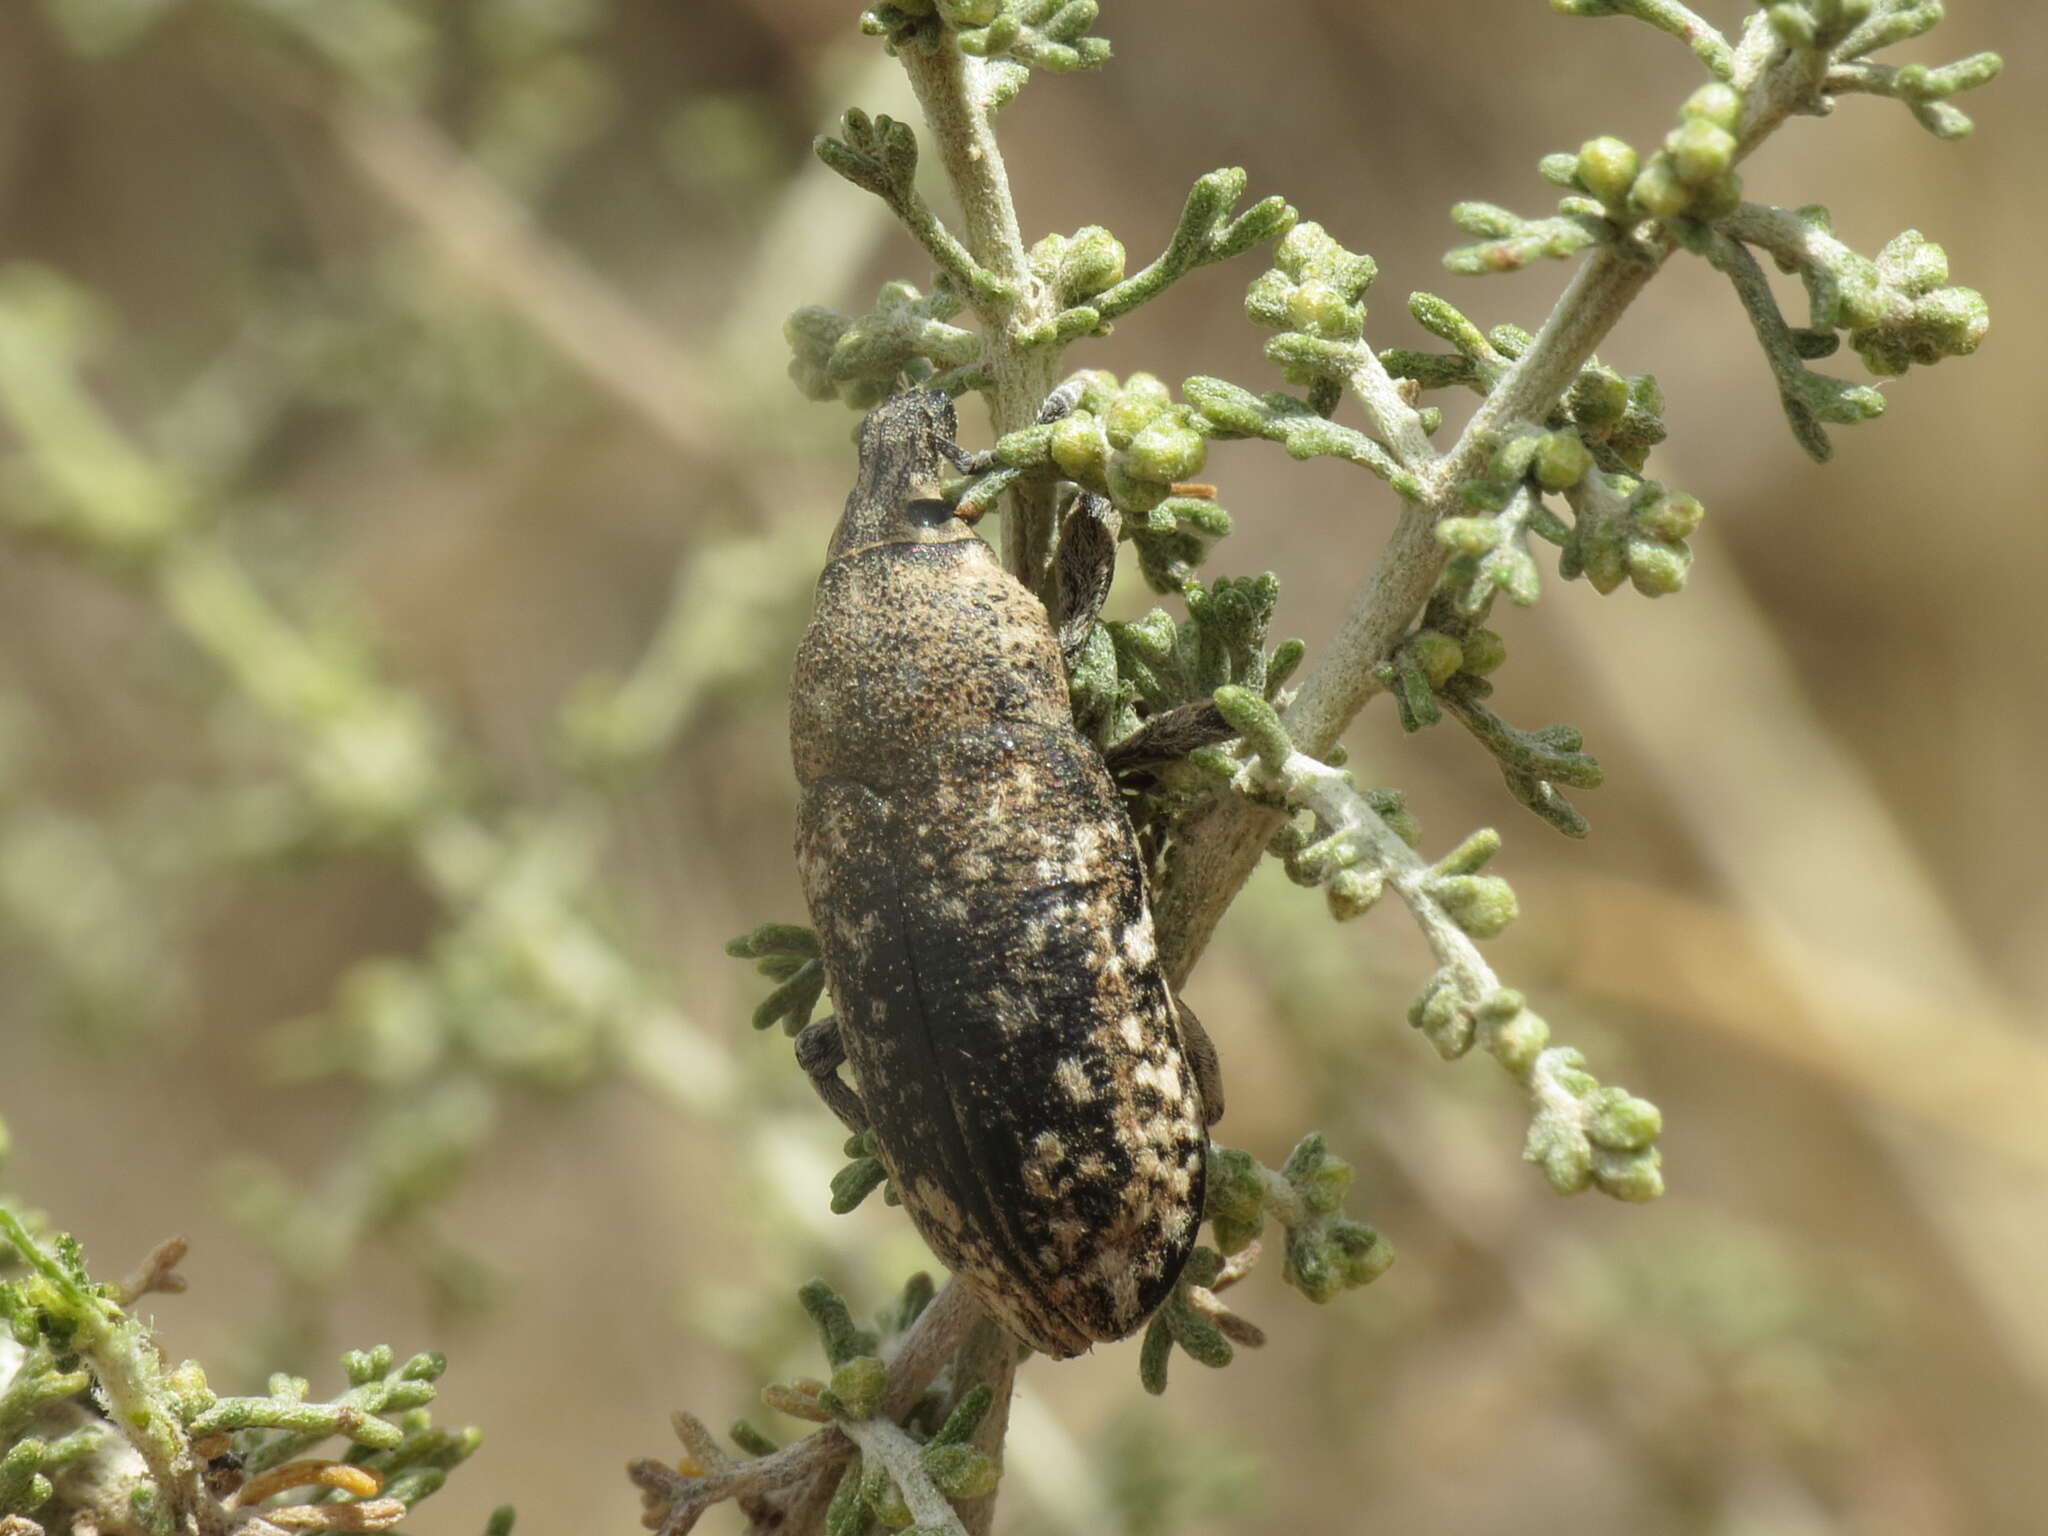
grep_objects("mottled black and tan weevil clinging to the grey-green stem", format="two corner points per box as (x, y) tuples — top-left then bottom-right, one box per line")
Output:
(791, 391), (1223, 1358)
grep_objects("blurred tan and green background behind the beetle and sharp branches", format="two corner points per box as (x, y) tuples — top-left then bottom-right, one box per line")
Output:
(0, 0), (2048, 1536)
